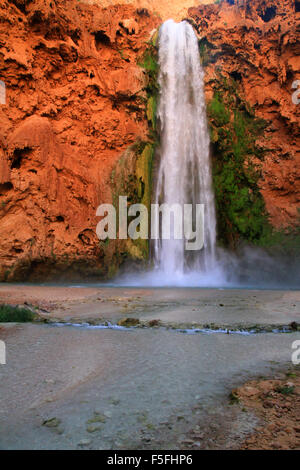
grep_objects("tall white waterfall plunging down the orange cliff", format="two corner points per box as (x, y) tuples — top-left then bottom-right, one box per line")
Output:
(154, 20), (217, 282)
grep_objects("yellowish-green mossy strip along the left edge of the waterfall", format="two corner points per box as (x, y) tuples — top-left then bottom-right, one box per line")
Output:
(108, 31), (159, 270)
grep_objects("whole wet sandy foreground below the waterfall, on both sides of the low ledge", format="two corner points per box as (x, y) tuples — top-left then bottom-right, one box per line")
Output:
(0, 285), (300, 449)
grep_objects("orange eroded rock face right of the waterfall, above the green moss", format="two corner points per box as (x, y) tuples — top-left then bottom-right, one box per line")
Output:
(189, 0), (300, 227)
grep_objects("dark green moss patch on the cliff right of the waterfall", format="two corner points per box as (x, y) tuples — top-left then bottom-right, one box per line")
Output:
(207, 75), (269, 246)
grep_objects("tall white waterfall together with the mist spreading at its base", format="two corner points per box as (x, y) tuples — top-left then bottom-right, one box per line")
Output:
(113, 20), (300, 288)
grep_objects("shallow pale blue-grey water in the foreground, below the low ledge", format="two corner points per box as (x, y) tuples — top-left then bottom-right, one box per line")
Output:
(0, 325), (299, 449)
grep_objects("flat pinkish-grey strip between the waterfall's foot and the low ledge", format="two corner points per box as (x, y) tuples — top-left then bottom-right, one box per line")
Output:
(0, 284), (300, 327)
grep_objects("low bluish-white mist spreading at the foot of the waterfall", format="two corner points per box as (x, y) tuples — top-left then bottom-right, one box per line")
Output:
(113, 245), (300, 290)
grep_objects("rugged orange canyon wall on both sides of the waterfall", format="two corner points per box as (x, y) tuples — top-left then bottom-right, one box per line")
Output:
(0, 0), (300, 280)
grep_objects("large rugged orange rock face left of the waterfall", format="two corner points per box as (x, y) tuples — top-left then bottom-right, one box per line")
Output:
(0, 0), (159, 280)
